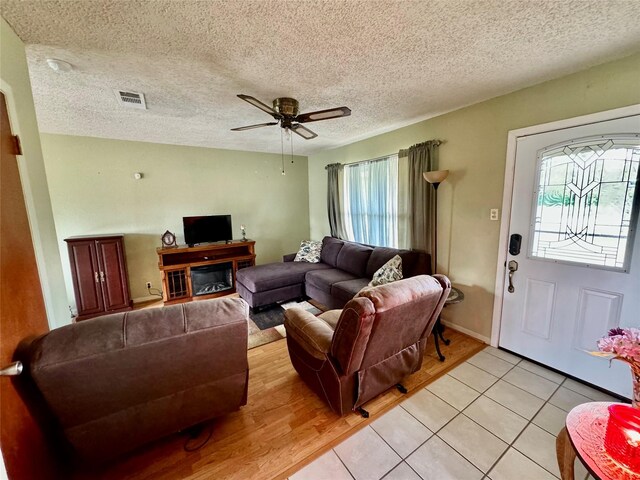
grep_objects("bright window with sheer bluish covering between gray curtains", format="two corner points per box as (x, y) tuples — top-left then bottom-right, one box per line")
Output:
(343, 155), (398, 248)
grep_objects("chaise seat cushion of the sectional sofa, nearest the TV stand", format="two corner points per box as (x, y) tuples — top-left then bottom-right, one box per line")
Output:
(236, 262), (331, 292)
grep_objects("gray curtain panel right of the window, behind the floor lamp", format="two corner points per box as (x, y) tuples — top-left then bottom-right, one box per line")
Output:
(398, 141), (439, 272)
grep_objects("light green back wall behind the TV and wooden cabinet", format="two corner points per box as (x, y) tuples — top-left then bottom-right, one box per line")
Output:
(42, 134), (309, 316)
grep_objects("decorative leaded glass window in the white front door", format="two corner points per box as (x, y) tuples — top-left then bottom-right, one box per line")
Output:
(530, 135), (640, 271)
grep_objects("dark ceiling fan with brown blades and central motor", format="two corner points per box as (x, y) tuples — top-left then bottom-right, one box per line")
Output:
(231, 94), (351, 140)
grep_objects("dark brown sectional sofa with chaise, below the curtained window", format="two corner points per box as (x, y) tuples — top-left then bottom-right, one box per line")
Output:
(236, 237), (431, 308)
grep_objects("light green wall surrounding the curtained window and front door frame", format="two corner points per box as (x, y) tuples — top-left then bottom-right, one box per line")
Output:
(309, 55), (640, 339)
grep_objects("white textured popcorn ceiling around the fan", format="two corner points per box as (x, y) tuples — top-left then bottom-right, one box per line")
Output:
(0, 0), (640, 154)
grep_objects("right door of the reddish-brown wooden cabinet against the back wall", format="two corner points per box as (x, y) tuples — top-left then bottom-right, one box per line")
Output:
(96, 239), (130, 312)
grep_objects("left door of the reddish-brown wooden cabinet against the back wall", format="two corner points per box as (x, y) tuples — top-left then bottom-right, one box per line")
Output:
(69, 240), (104, 315)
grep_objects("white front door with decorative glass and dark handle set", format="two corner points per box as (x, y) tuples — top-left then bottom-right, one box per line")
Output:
(499, 115), (640, 397)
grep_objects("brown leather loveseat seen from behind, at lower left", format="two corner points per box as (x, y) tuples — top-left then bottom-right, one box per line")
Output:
(21, 299), (249, 460)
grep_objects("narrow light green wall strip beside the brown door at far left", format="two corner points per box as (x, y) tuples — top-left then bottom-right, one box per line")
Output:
(0, 18), (70, 328)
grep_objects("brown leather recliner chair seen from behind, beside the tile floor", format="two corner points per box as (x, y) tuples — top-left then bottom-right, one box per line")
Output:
(284, 275), (451, 416)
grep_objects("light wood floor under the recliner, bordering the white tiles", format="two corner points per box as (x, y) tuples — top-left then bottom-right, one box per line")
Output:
(75, 329), (484, 480)
